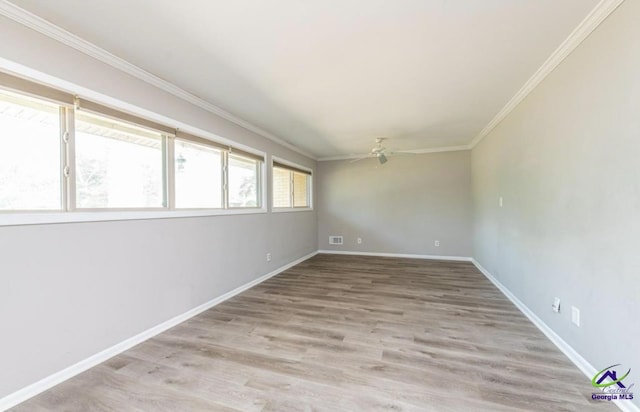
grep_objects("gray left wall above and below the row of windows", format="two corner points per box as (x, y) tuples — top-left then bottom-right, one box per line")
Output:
(0, 14), (317, 398)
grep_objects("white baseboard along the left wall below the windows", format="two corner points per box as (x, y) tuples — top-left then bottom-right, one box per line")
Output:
(0, 252), (318, 411)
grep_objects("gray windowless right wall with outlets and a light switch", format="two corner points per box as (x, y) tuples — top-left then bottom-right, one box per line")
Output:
(472, 0), (640, 402)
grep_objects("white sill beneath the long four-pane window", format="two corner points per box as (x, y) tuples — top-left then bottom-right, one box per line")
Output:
(0, 208), (267, 227)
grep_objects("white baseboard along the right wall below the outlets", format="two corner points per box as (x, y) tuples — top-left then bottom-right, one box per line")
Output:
(471, 259), (640, 412)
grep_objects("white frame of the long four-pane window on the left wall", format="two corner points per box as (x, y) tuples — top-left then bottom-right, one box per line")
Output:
(0, 72), (268, 227)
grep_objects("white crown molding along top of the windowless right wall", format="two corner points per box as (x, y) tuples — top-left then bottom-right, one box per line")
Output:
(469, 0), (624, 149)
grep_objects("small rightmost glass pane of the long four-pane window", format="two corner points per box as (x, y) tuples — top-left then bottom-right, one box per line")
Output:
(228, 153), (261, 208)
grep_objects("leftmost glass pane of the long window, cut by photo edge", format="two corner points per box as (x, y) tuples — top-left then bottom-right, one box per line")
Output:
(0, 91), (62, 210)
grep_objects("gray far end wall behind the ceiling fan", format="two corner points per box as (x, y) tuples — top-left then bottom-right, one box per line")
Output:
(316, 151), (472, 256)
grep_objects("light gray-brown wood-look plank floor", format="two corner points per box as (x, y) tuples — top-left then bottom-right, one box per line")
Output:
(15, 255), (616, 412)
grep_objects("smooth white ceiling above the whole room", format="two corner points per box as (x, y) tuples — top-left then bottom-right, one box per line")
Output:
(12, 0), (598, 158)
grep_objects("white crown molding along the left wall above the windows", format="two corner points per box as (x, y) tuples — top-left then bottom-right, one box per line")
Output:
(0, 0), (316, 160)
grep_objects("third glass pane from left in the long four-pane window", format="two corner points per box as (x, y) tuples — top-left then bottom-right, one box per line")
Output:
(174, 140), (222, 209)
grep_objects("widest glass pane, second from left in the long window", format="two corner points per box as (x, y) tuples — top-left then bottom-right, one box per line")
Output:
(75, 113), (165, 209)
